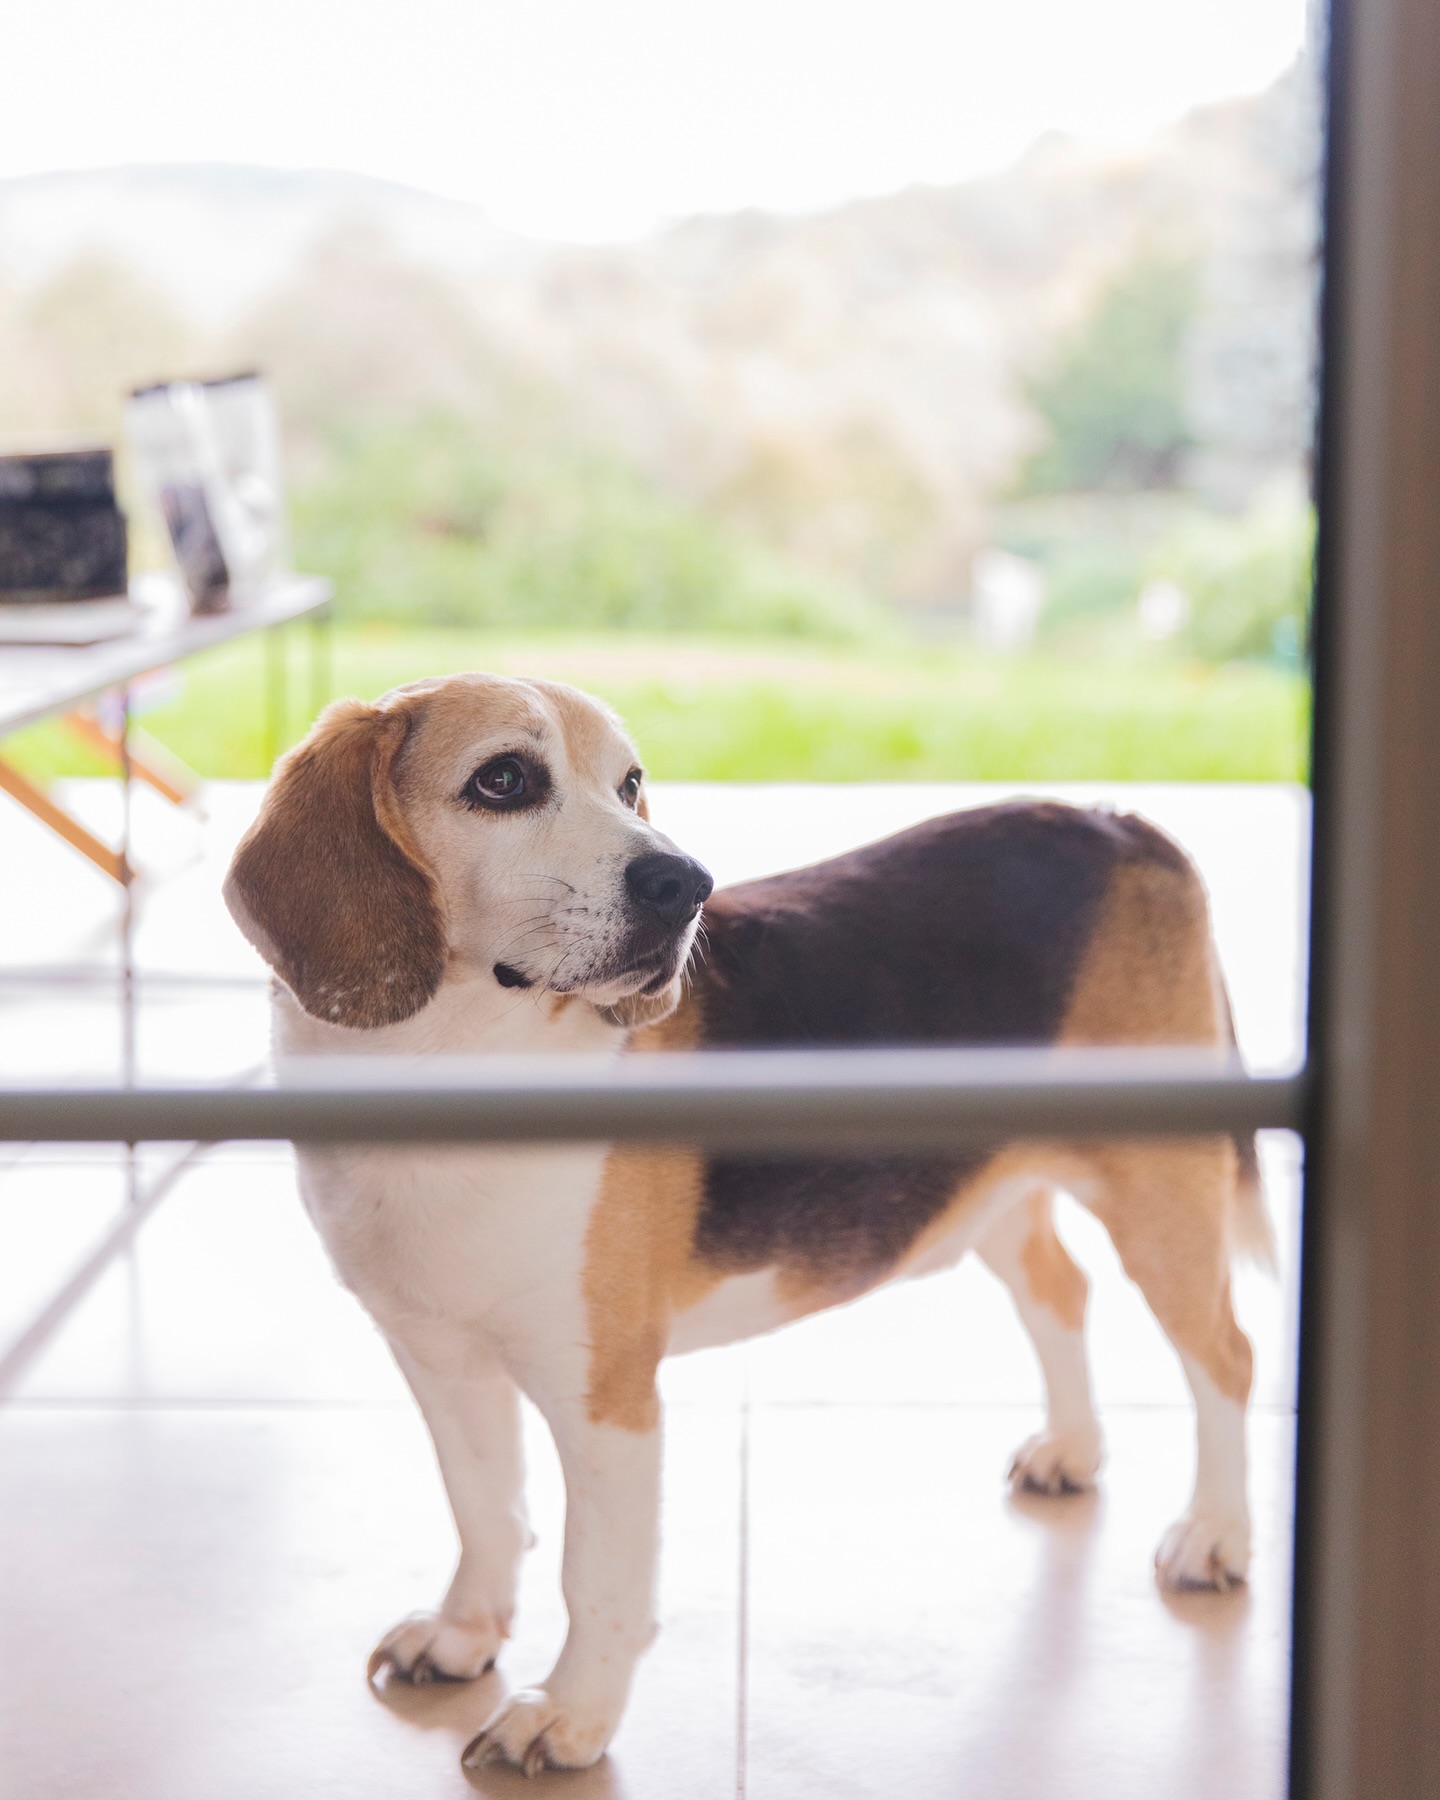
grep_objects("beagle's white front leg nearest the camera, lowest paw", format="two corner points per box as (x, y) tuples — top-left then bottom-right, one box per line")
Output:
(463, 1393), (661, 1775)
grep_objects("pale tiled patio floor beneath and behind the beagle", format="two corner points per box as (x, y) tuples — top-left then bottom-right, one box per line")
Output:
(0, 787), (1303, 1800)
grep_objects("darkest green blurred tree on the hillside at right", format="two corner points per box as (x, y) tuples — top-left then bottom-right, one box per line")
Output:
(1021, 254), (1199, 493)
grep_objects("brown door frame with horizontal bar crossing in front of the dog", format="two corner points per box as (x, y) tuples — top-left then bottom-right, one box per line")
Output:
(0, 0), (1440, 1778)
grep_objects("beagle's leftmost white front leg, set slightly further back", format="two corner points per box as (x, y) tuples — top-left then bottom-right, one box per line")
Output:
(369, 1345), (531, 1681)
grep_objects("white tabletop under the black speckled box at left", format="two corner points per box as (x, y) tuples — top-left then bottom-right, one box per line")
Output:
(0, 574), (333, 738)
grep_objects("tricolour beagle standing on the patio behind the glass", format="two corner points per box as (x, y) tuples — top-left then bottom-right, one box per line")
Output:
(225, 675), (1267, 1773)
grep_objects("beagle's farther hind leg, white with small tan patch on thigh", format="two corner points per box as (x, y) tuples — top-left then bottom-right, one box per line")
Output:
(977, 1186), (1102, 1494)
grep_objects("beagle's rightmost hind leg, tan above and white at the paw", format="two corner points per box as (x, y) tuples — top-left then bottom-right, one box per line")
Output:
(1076, 1138), (1253, 1589)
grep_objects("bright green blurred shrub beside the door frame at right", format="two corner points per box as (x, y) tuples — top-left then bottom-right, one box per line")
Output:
(1150, 497), (1314, 664)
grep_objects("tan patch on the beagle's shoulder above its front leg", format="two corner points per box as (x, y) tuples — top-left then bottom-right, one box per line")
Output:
(581, 1001), (722, 1431)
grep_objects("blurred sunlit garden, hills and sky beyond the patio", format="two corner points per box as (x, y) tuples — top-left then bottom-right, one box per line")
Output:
(0, 0), (1318, 779)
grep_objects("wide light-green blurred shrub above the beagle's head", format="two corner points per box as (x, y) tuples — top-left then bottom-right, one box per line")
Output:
(293, 414), (882, 639)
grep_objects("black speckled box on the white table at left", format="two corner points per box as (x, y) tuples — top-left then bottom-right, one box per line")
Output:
(0, 448), (128, 605)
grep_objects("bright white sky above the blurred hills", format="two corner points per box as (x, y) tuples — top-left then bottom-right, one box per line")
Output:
(0, 0), (1307, 239)
